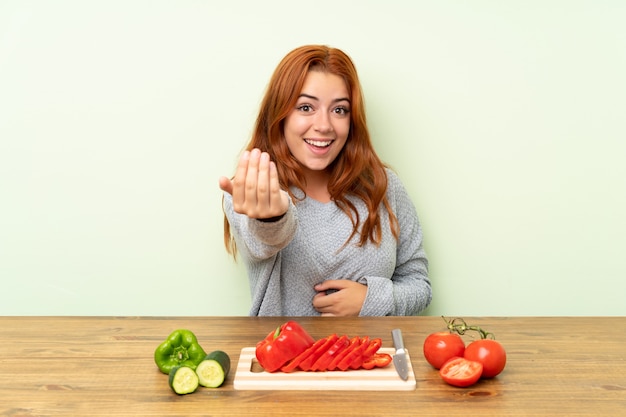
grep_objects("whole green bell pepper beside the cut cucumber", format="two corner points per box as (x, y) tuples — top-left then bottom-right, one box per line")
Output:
(154, 329), (206, 374)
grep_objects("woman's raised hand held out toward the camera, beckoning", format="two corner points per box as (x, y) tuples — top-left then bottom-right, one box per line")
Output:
(219, 149), (289, 219)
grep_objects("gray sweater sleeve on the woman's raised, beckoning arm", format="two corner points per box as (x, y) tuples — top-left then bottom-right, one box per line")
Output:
(223, 193), (298, 260)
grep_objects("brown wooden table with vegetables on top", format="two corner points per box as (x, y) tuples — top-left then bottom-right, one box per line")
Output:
(0, 317), (626, 417)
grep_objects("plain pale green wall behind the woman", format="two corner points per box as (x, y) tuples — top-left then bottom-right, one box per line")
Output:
(0, 0), (626, 316)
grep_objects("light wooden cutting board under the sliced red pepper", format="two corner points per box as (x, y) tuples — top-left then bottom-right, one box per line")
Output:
(234, 347), (416, 391)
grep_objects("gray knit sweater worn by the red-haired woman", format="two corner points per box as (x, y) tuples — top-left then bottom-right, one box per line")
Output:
(224, 170), (432, 316)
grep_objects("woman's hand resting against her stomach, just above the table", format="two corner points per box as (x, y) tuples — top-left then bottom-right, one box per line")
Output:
(313, 279), (367, 316)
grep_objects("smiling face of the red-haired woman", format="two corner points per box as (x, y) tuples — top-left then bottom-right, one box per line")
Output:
(284, 70), (350, 171)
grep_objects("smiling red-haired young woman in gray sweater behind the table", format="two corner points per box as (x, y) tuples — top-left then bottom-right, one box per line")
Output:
(219, 45), (432, 316)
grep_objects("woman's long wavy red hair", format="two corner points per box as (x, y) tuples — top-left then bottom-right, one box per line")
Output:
(224, 45), (399, 256)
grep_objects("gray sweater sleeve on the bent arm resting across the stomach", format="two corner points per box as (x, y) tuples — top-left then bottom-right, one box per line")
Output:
(360, 173), (432, 316)
